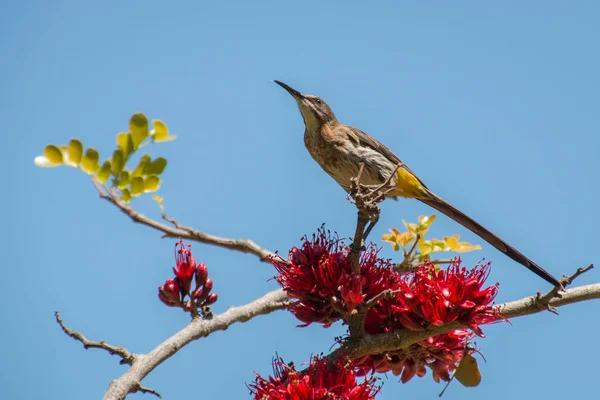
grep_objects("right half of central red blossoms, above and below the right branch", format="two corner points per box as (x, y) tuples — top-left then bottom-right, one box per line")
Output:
(354, 258), (504, 382)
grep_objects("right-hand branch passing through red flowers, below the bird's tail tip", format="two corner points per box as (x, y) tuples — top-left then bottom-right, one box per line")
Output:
(327, 283), (600, 359)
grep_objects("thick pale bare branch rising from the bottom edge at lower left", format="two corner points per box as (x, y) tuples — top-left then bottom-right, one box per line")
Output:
(103, 289), (288, 400)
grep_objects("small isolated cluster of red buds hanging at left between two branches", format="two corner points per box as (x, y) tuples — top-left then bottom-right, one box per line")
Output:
(158, 240), (218, 313)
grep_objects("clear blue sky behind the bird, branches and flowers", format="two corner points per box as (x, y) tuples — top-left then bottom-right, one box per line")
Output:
(0, 0), (600, 400)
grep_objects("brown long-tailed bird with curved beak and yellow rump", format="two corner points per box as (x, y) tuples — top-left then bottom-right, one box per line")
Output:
(274, 80), (562, 287)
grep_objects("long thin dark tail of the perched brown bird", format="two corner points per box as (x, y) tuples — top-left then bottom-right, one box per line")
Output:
(418, 189), (560, 286)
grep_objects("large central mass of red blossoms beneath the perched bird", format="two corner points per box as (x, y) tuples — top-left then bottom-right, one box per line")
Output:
(273, 229), (503, 382)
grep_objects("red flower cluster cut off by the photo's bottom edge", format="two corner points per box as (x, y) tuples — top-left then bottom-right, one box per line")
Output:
(249, 358), (378, 400)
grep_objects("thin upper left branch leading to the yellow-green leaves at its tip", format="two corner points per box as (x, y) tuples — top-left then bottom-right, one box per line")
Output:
(92, 180), (274, 262)
